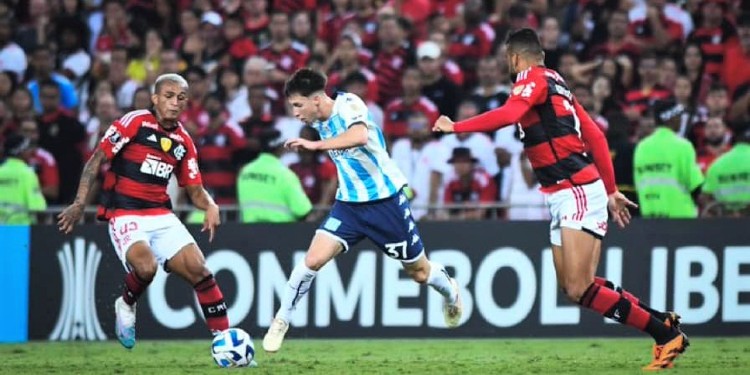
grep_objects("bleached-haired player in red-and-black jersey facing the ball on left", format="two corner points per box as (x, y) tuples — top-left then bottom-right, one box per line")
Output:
(58, 74), (229, 349)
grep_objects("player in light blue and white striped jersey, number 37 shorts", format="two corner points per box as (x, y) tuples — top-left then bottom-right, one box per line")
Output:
(263, 69), (462, 352)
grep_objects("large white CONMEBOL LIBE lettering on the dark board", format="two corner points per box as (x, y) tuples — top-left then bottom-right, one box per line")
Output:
(148, 246), (750, 329)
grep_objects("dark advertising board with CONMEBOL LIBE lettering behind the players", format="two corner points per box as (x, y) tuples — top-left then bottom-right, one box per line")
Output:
(0, 219), (750, 341)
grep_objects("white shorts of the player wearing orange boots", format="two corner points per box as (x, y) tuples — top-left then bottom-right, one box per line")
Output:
(547, 180), (609, 246)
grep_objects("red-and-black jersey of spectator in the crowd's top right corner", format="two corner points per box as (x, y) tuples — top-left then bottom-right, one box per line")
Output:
(688, 20), (737, 76)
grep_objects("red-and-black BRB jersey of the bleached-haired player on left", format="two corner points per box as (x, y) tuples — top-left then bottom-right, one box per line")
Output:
(97, 110), (203, 219)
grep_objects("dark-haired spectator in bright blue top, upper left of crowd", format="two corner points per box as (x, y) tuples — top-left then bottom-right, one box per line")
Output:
(27, 45), (78, 113)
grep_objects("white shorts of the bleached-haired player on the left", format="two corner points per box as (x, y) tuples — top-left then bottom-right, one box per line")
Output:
(109, 213), (195, 271)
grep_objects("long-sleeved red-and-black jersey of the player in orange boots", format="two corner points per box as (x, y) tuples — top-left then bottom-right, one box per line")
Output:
(454, 66), (616, 193)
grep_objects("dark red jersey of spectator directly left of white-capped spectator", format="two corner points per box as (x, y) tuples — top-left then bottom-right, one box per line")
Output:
(372, 42), (415, 107)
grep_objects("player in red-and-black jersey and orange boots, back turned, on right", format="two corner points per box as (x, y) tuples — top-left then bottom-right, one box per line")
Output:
(433, 29), (688, 369)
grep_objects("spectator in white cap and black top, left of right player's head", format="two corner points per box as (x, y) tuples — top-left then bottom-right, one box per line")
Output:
(417, 41), (461, 118)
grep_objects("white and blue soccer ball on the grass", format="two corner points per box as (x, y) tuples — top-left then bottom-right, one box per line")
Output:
(211, 328), (255, 368)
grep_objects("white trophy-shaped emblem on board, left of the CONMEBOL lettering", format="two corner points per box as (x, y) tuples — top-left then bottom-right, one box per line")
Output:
(49, 237), (107, 341)
